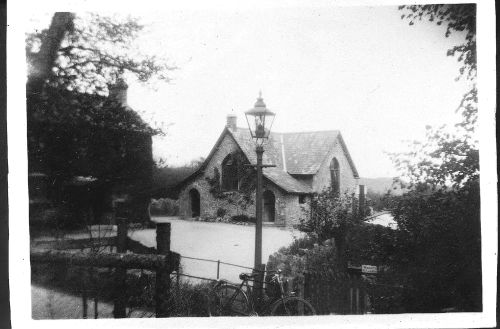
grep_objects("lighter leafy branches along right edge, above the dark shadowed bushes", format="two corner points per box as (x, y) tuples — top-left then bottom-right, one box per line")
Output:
(391, 4), (479, 188)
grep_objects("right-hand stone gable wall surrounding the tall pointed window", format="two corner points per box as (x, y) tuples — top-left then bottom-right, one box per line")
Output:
(313, 139), (358, 194)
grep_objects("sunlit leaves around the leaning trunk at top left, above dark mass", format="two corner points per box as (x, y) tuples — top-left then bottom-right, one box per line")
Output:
(26, 13), (174, 94)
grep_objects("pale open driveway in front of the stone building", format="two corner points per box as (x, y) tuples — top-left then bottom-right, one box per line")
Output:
(130, 217), (301, 282)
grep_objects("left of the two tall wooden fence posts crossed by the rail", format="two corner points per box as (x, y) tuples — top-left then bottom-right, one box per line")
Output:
(113, 209), (127, 318)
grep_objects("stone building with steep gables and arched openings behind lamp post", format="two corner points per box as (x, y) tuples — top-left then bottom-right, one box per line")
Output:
(179, 93), (359, 226)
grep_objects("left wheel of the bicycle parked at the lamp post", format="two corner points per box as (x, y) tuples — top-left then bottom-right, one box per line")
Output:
(210, 284), (251, 316)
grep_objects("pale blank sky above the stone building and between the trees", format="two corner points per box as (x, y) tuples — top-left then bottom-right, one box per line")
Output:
(28, 6), (467, 177)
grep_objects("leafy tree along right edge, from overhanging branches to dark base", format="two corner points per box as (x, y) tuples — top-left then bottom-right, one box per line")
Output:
(372, 4), (482, 312)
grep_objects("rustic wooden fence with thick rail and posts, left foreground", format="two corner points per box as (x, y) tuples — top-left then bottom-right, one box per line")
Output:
(30, 218), (180, 318)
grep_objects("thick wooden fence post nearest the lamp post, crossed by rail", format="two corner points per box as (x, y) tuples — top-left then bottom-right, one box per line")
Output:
(155, 223), (171, 318)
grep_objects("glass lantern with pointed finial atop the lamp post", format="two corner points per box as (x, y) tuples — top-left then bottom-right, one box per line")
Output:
(245, 93), (275, 145)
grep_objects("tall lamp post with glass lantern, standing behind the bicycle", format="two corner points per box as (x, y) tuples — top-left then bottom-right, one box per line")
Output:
(245, 93), (275, 276)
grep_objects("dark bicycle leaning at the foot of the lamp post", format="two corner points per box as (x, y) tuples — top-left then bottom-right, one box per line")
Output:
(209, 270), (316, 316)
